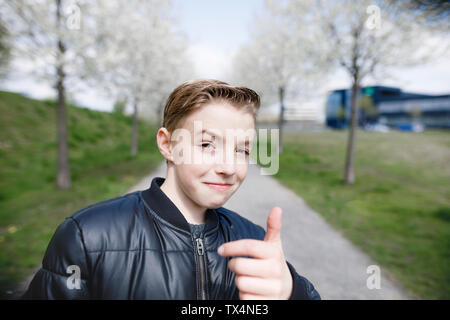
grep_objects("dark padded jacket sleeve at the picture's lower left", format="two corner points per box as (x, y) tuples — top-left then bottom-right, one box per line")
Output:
(22, 217), (90, 300)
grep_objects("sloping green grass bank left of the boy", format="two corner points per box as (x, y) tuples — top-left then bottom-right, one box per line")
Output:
(0, 91), (163, 296)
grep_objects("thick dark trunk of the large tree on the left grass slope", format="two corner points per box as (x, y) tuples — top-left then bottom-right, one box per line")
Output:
(56, 0), (72, 189)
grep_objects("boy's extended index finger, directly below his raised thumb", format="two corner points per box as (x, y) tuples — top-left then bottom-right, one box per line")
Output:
(217, 239), (278, 259)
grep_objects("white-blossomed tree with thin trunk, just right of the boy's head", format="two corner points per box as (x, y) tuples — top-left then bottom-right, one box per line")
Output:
(230, 1), (326, 154)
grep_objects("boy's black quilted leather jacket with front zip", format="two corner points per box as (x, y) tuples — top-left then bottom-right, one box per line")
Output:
(22, 177), (320, 300)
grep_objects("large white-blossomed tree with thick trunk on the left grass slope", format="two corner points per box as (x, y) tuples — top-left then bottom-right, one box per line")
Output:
(2, 0), (96, 189)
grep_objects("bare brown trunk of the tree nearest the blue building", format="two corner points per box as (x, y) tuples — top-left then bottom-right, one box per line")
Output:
(344, 77), (359, 184)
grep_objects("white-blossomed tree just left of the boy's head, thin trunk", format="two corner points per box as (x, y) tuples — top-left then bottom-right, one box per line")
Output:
(81, 0), (191, 155)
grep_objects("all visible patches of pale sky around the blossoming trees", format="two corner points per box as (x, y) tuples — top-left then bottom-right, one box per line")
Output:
(1, 0), (450, 111)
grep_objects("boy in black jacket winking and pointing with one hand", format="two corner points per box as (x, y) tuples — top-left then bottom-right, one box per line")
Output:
(24, 80), (320, 299)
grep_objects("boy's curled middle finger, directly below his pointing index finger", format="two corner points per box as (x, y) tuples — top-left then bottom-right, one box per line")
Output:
(228, 258), (282, 278)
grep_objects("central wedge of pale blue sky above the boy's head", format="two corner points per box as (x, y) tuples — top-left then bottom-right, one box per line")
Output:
(175, 0), (264, 78)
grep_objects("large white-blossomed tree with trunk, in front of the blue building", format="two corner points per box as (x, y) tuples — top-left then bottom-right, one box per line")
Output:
(284, 0), (445, 184)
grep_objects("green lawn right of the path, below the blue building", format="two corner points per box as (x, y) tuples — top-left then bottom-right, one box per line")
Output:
(255, 131), (450, 299)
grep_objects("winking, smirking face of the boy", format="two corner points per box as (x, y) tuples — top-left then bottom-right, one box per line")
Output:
(167, 101), (255, 209)
